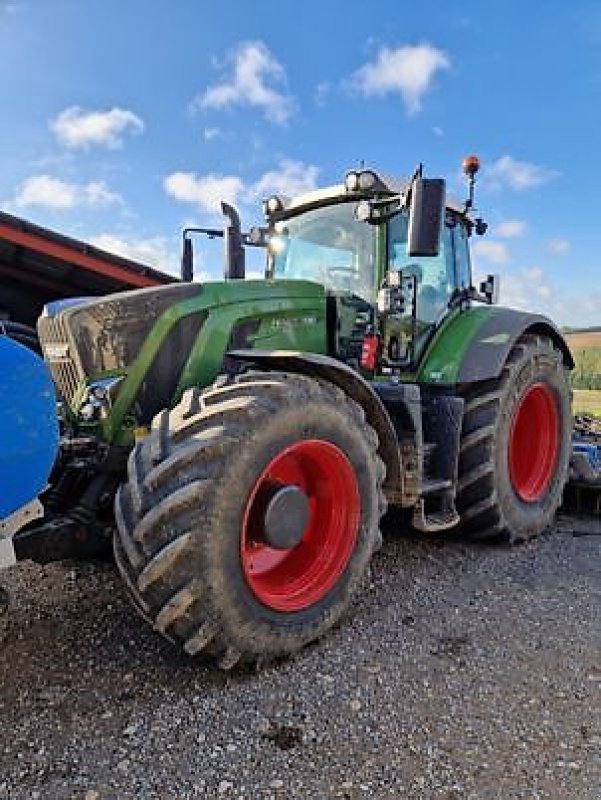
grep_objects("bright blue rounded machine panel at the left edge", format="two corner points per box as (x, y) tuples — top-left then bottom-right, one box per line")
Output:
(0, 336), (59, 525)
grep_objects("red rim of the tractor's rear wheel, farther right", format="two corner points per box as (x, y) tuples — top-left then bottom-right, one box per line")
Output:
(509, 383), (559, 503)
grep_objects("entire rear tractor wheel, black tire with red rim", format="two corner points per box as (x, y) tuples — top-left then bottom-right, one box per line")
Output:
(457, 334), (572, 542)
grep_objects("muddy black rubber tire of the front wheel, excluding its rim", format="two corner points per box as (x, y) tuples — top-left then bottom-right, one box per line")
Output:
(115, 373), (386, 669)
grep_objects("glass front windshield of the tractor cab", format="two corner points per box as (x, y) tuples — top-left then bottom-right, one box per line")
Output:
(270, 202), (376, 303)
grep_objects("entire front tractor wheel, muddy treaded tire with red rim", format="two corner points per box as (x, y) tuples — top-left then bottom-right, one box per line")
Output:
(115, 373), (385, 669)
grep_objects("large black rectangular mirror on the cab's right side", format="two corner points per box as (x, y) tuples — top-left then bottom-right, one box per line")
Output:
(407, 178), (445, 257)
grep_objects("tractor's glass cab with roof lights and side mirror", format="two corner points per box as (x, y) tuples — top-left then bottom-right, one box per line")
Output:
(264, 164), (485, 372)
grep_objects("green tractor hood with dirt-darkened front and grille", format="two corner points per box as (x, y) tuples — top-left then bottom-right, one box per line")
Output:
(38, 280), (326, 444)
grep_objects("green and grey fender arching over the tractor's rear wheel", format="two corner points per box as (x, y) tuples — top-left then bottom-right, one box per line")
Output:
(417, 306), (574, 385)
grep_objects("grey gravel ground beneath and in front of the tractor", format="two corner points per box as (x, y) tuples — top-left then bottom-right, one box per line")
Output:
(0, 517), (601, 800)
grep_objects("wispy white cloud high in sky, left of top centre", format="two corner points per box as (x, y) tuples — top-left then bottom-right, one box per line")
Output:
(193, 42), (295, 125)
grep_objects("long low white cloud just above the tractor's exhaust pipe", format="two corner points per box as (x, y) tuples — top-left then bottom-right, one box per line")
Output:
(163, 158), (319, 213)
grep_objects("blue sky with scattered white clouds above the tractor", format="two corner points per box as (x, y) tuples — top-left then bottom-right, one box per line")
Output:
(0, 0), (601, 325)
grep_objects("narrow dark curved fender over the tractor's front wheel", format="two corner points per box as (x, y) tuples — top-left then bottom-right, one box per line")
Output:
(228, 350), (404, 498)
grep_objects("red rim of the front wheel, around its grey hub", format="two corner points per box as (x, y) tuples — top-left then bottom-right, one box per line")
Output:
(240, 439), (361, 611)
